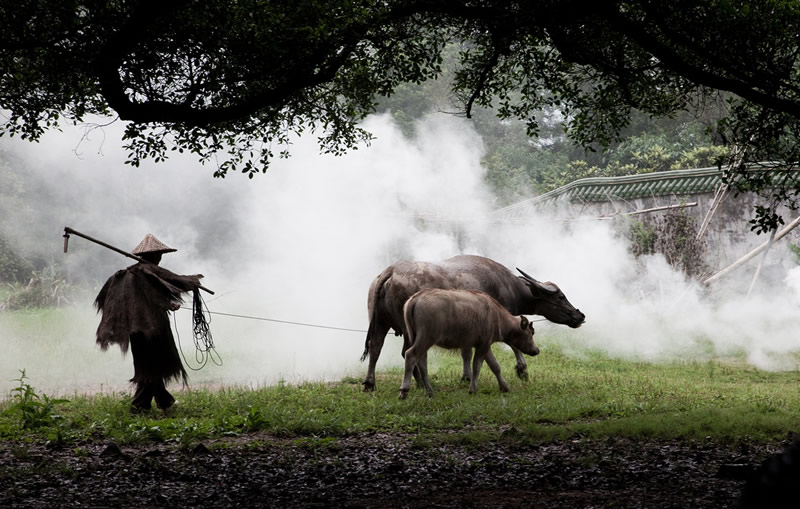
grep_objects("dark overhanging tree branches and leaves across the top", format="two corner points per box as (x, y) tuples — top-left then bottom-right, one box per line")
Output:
(0, 0), (800, 228)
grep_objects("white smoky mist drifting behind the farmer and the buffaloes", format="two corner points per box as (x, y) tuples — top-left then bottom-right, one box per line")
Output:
(0, 112), (800, 394)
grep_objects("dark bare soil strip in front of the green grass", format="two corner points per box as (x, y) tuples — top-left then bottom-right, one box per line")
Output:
(0, 434), (785, 509)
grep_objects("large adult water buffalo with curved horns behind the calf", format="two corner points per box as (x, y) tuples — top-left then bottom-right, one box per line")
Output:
(361, 255), (586, 391)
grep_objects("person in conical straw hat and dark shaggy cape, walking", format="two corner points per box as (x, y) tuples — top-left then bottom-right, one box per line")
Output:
(95, 233), (203, 412)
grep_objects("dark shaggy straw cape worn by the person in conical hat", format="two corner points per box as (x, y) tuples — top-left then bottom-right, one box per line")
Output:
(95, 263), (201, 384)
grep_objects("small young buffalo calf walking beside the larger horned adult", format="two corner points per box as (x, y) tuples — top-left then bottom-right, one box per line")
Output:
(400, 288), (539, 399)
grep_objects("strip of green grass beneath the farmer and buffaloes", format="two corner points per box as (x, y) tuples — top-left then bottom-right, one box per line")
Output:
(0, 345), (800, 446)
